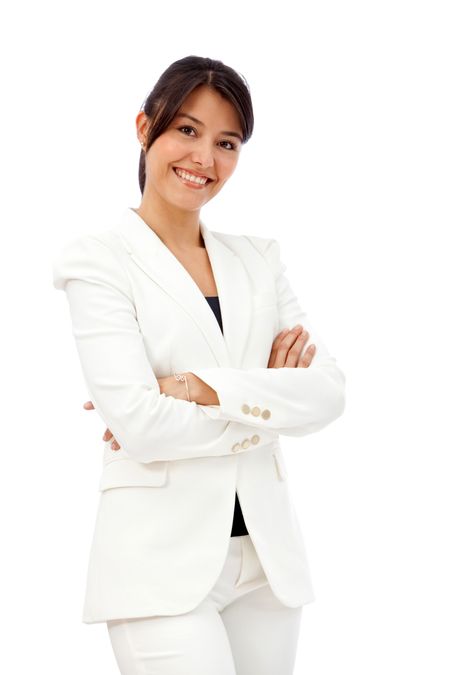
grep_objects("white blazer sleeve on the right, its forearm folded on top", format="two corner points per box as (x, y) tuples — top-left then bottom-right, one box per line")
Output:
(188, 237), (345, 436)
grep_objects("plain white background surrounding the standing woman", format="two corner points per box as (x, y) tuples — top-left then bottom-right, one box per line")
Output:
(0, 0), (450, 675)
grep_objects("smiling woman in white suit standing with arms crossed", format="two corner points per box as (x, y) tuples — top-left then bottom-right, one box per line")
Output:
(54, 56), (345, 675)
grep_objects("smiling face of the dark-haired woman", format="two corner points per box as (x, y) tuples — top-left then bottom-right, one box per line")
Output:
(136, 85), (242, 211)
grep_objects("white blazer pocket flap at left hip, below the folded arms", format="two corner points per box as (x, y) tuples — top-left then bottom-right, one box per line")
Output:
(98, 458), (169, 491)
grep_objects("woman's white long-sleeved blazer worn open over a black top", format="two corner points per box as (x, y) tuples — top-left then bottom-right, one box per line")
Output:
(53, 208), (345, 623)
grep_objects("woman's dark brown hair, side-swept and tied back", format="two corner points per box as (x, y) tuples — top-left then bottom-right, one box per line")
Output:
(139, 56), (254, 194)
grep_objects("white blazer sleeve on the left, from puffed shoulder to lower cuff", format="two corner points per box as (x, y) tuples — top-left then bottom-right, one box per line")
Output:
(53, 234), (277, 462)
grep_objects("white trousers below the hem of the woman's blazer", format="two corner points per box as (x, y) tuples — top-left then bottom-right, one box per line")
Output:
(107, 535), (302, 675)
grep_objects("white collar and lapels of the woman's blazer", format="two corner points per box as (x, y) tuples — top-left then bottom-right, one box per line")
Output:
(114, 207), (252, 368)
